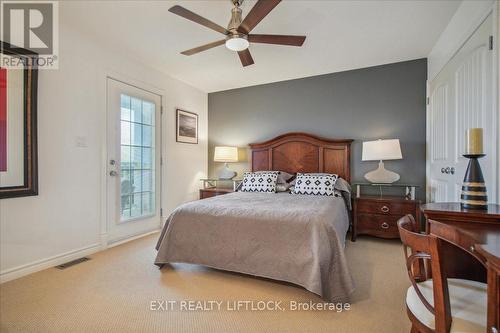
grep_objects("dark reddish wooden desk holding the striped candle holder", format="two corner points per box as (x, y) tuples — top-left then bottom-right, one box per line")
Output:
(421, 203), (500, 332)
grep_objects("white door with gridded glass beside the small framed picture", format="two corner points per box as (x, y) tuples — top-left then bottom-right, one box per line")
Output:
(107, 78), (161, 242)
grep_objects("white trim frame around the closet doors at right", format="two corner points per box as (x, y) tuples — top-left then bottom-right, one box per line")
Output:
(425, 1), (500, 204)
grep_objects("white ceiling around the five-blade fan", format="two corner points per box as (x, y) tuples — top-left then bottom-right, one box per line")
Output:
(60, 0), (460, 92)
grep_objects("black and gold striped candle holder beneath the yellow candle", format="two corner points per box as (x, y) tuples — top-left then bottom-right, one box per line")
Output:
(460, 154), (488, 209)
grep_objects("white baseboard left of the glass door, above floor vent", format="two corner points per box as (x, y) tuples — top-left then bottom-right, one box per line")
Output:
(0, 243), (101, 283)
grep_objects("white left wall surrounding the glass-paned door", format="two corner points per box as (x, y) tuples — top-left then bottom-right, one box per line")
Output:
(0, 20), (207, 281)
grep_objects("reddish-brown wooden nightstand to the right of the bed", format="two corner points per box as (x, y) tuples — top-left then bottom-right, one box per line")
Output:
(351, 196), (420, 242)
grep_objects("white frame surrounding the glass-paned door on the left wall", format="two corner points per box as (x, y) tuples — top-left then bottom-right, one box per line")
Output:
(99, 70), (166, 250)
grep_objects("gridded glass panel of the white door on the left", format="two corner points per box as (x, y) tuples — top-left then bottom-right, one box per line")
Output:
(120, 94), (156, 221)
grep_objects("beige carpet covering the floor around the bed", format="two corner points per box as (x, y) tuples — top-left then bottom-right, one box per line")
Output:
(0, 234), (410, 333)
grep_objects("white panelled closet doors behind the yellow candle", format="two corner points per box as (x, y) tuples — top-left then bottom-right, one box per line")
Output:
(428, 14), (498, 202)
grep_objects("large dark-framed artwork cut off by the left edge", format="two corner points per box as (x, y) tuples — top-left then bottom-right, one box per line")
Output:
(0, 42), (38, 199)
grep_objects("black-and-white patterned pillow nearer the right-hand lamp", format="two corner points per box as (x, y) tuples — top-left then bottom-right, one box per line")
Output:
(291, 173), (338, 196)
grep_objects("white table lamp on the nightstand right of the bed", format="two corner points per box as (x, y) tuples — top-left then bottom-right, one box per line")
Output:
(361, 139), (403, 184)
